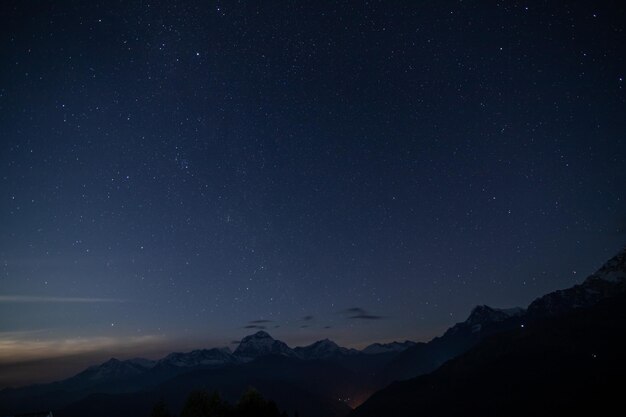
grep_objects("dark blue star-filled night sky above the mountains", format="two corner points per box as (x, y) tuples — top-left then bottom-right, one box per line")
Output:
(0, 0), (626, 386)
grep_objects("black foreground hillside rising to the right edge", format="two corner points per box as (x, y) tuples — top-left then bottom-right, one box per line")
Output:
(351, 293), (626, 417)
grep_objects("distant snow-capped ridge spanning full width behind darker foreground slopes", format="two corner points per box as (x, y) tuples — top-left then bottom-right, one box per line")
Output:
(6, 245), (626, 414)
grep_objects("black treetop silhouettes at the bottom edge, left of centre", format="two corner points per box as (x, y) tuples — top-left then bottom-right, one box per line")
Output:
(150, 388), (298, 417)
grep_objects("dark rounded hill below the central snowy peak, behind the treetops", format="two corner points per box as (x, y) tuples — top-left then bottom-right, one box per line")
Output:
(55, 355), (373, 417)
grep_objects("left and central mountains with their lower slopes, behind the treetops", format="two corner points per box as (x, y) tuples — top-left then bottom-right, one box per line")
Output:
(0, 331), (412, 417)
